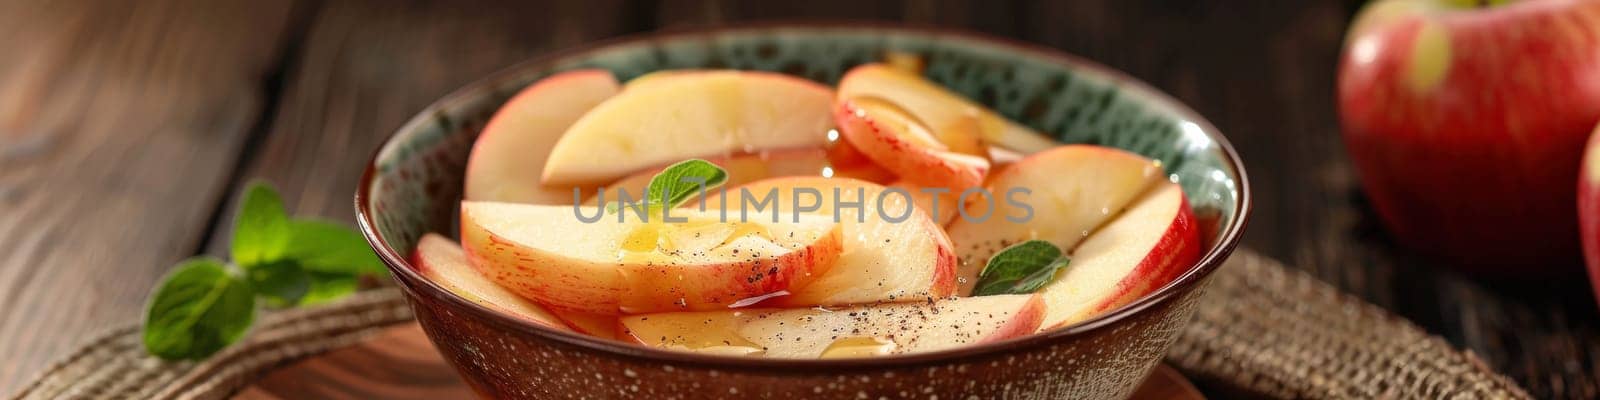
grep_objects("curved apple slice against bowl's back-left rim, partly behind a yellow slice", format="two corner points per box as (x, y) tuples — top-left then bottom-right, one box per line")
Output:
(466, 69), (619, 205)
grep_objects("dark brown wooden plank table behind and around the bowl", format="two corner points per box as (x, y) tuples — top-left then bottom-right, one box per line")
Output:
(0, 0), (1600, 398)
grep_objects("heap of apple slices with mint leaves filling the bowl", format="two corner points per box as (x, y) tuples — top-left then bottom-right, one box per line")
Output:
(418, 64), (1202, 358)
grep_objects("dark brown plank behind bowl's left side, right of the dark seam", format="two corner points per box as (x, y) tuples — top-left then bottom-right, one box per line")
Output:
(211, 0), (635, 254)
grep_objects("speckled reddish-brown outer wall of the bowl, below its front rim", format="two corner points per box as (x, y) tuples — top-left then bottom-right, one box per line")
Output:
(411, 265), (1203, 398)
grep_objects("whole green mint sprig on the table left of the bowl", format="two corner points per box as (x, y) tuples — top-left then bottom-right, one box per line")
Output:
(142, 182), (382, 360)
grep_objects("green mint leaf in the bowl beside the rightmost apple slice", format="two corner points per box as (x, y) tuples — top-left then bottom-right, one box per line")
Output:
(973, 240), (1072, 296)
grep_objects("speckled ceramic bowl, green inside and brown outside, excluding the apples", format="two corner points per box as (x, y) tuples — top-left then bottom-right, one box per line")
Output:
(355, 24), (1250, 398)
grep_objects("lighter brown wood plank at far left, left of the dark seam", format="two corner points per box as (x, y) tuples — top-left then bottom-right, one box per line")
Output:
(0, 0), (291, 394)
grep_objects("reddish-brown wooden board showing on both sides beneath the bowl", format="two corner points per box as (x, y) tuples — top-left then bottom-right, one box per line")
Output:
(234, 323), (1205, 400)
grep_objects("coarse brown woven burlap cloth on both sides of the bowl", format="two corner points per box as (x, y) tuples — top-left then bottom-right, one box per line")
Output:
(14, 250), (1528, 398)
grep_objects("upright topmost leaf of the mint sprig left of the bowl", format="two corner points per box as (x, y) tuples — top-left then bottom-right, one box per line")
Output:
(232, 182), (290, 267)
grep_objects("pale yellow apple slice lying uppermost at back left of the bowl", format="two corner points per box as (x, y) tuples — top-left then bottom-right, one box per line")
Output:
(544, 70), (834, 184)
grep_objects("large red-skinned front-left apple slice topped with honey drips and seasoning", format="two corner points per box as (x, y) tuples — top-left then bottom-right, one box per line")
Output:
(461, 202), (842, 315)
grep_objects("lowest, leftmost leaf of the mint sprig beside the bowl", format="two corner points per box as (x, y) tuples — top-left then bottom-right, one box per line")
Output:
(142, 258), (256, 360)
